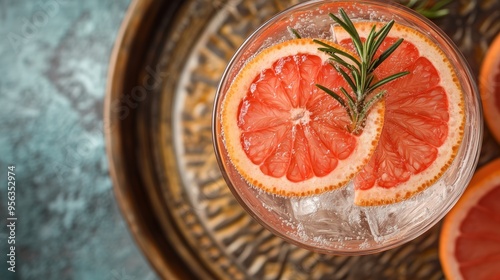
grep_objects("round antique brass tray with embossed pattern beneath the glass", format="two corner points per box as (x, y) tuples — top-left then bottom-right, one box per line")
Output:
(107, 0), (500, 279)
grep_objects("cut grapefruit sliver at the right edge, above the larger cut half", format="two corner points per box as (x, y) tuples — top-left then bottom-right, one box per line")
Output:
(479, 34), (500, 143)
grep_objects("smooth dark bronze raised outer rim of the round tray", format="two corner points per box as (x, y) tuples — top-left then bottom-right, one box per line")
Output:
(103, 0), (208, 279)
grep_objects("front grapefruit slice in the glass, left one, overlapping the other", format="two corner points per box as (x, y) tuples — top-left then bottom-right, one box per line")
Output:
(221, 39), (384, 196)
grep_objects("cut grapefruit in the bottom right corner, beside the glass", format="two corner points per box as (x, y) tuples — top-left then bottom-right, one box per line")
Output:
(439, 159), (500, 280)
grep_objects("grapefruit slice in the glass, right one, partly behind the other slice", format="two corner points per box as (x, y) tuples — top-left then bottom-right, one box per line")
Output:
(334, 22), (465, 205)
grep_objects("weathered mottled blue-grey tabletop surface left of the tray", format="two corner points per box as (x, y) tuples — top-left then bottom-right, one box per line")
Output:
(0, 0), (156, 279)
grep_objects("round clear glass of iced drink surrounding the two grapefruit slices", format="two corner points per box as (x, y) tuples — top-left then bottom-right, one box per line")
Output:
(212, 0), (483, 255)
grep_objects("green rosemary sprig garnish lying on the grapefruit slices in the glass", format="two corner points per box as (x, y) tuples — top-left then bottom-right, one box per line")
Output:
(314, 9), (409, 134)
